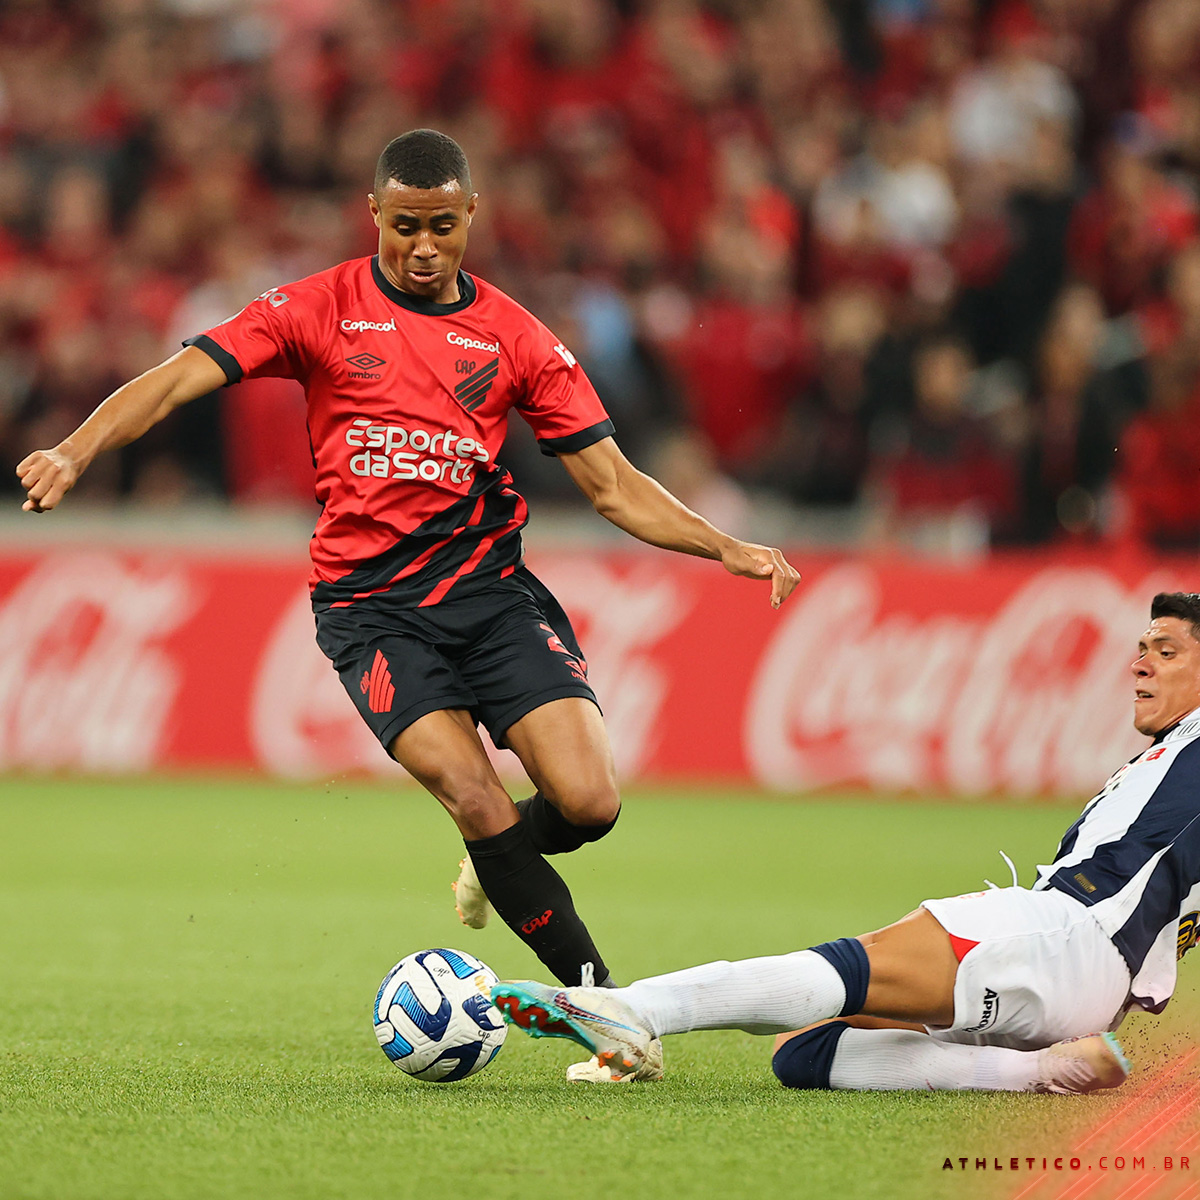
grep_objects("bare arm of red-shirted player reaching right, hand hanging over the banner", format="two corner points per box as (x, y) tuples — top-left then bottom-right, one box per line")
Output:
(558, 438), (800, 608)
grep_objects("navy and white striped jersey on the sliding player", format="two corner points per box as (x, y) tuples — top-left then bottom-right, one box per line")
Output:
(1033, 708), (1200, 1013)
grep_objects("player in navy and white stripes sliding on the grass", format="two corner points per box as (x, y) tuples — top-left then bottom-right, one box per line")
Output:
(492, 592), (1200, 1092)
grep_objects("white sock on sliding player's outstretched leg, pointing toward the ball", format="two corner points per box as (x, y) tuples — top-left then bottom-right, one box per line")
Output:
(614, 950), (846, 1037)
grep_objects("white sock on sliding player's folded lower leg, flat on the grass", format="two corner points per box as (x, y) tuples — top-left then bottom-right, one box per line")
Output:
(829, 1030), (1040, 1092)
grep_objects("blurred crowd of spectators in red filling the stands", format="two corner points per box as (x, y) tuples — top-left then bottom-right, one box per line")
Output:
(0, 0), (1200, 550)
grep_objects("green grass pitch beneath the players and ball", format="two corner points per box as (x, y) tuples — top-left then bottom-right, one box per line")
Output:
(0, 779), (1200, 1200)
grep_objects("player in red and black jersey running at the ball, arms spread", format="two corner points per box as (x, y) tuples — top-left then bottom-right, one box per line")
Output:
(17, 130), (799, 984)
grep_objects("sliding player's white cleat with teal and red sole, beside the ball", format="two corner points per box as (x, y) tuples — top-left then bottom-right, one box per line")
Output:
(492, 982), (661, 1082)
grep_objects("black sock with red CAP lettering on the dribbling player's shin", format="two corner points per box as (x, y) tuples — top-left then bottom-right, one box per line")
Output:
(463, 821), (608, 986)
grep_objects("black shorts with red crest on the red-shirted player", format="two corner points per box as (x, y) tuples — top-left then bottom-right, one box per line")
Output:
(317, 568), (599, 754)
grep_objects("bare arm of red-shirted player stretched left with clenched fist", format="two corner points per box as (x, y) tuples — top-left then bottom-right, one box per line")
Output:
(17, 346), (226, 512)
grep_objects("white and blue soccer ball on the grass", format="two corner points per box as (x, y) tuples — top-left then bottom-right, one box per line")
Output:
(374, 950), (508, 1084)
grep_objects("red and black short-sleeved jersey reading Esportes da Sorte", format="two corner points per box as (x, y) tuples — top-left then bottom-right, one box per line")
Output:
(192, 258), (613, 611)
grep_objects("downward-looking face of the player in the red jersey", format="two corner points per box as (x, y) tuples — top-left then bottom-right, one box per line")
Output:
(367, 180), (478, 304)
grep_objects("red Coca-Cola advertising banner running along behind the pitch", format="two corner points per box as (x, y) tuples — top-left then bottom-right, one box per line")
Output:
(0, 547), (1200, 794)
